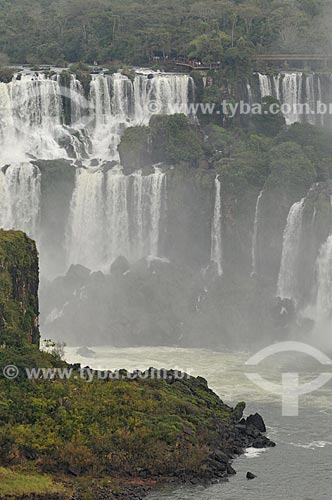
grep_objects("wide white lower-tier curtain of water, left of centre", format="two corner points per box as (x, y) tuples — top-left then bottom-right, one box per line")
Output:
(67, 167), (165, 271)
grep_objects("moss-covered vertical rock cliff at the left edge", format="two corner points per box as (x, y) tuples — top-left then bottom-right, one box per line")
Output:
(0, 230), (39, 346)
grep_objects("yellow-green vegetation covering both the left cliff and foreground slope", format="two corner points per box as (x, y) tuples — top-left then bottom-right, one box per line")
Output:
(0, 230), (238, 494)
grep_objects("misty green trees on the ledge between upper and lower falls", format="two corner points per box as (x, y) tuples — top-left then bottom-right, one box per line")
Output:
(119, 113), (332, 203)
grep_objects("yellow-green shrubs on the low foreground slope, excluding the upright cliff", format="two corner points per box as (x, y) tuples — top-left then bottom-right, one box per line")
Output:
(0, 350), (232, 476)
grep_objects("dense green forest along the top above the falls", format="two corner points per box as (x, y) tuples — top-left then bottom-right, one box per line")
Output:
(0, 0), (332, 64)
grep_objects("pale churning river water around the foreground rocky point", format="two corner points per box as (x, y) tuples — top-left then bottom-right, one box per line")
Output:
(66, 346), (332, 500)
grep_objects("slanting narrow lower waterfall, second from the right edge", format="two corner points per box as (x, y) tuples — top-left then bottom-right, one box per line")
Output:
(277, 198), (304, 300)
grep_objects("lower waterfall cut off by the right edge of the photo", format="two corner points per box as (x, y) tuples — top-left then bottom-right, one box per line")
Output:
(316, 235), (332, 321)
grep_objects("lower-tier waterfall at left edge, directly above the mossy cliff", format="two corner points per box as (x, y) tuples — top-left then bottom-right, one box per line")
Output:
(0, 163), (41, 238)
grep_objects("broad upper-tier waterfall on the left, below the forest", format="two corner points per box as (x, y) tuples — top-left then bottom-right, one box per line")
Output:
(0, 70), (192, 166)
